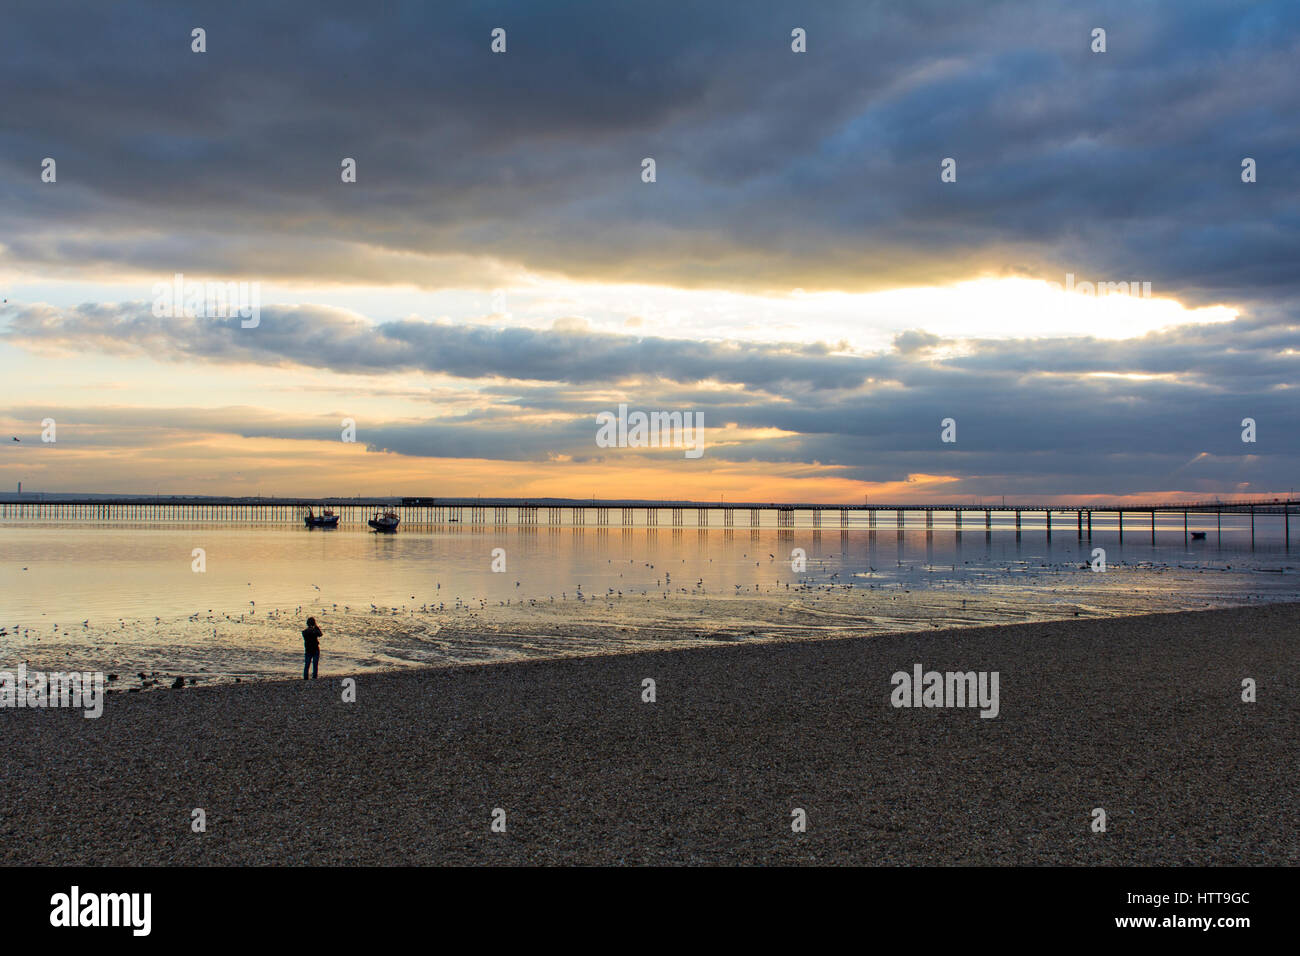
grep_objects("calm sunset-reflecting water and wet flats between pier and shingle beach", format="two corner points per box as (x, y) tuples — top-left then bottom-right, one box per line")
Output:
(0, 516), (1300, 685)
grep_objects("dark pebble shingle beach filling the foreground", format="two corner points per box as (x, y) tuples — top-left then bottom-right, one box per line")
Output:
(0, 604), (1300, 865)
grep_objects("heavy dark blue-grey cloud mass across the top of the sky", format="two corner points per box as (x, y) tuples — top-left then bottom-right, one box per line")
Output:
(0, 0), (1300, 300)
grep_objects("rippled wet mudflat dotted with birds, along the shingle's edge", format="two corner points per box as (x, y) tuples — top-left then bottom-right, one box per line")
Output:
(10, 570), (1300, 693)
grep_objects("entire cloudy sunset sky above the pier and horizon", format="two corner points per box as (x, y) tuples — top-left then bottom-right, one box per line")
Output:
(0, 0), (1300, 503)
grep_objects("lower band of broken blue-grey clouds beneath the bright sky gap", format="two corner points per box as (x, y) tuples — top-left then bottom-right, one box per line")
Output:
(4, 304), (1300, 496)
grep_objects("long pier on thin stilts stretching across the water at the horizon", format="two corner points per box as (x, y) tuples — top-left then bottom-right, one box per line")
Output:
(0, 493), (1300, 548)
